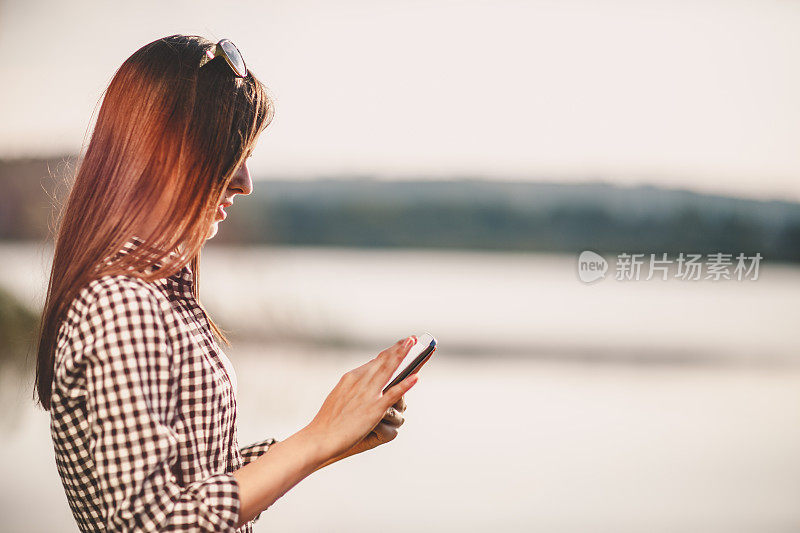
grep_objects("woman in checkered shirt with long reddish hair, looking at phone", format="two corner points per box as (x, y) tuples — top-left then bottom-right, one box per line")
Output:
(36, 35), (417, 531)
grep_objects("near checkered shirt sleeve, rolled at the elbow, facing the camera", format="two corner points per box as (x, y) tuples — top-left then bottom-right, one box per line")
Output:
(86, 280), (240, 532)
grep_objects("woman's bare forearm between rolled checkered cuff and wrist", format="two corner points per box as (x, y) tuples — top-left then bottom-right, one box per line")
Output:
(233, 428), (329, 528)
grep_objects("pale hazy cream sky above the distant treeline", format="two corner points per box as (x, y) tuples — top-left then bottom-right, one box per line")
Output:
(0, 0), (800, 200)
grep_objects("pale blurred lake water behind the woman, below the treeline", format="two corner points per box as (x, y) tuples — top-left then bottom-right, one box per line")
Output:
(0, 244), (800, 532)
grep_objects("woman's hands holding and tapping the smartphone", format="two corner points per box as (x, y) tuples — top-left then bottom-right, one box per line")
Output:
(305, 336), (419, 466)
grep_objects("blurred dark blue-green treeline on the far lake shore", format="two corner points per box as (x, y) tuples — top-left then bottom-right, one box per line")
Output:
(0, 155), (800, 261)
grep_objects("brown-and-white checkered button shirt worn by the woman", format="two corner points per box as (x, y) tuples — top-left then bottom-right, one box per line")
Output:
(50, 237), (275, 532)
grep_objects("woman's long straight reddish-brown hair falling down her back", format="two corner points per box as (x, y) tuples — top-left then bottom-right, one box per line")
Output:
(34, 35), (274, 410)
